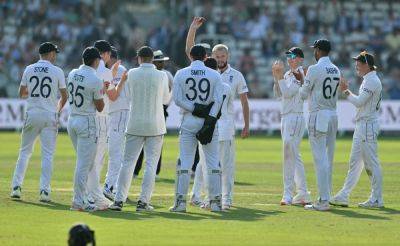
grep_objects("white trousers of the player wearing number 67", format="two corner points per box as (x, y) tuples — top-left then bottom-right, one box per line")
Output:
(308, 111), (338, 201)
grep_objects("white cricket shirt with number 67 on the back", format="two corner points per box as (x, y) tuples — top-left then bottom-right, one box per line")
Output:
(300, 56), (340, 112)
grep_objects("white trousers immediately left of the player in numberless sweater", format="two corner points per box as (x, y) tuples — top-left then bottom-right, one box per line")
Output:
(105, 110), (129, 190)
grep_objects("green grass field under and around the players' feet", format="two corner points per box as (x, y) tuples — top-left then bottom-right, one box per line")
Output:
(0, 132), (400, 245)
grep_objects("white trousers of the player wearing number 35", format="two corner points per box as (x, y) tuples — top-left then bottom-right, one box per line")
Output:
(67, 115), (97, 207)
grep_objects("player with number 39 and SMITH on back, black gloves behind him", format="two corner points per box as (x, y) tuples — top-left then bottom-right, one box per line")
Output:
(170, 45), (226, 212)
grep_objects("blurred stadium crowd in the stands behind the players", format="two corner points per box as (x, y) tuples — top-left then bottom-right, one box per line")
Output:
(0, 0), (400, 99)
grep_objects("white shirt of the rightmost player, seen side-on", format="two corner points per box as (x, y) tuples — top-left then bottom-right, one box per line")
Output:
(347, 71), (382, 121)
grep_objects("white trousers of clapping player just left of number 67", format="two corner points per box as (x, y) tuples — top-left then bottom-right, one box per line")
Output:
(281, 113), (307, 201)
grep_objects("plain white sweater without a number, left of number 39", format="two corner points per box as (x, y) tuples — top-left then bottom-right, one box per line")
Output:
(125, 63), (169, 136)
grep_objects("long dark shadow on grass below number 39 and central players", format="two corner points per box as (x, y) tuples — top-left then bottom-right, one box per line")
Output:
(92, 207), (285, 221)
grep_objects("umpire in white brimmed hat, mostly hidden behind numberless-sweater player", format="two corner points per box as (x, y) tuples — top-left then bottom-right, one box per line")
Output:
(133, 50), (174, 177)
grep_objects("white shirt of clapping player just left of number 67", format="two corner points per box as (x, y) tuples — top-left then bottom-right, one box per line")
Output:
(274, 67), (304, 115)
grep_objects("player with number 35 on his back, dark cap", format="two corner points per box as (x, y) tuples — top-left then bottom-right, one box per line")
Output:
(67, 47), (104, 212)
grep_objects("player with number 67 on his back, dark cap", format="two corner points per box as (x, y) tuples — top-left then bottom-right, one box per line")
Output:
(300, 39), (340, 211)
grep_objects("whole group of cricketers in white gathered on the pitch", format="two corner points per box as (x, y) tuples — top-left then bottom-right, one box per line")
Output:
(11, 17), (383, 212)
